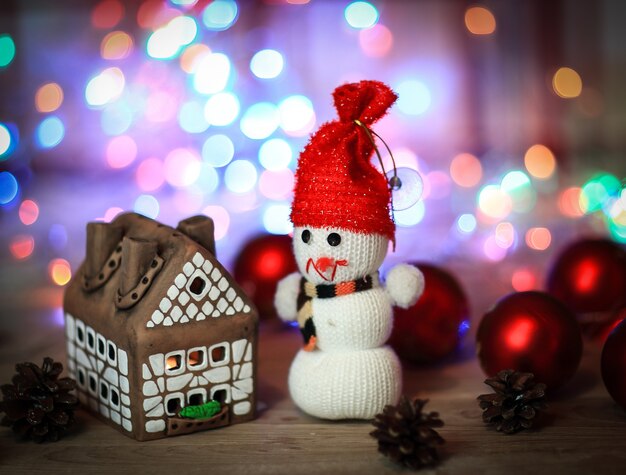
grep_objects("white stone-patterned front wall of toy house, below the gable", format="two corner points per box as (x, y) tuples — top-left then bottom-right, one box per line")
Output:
(142, 338), (254, 432)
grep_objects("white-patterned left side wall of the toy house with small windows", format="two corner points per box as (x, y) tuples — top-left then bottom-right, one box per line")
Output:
(65, 313), (133, 432)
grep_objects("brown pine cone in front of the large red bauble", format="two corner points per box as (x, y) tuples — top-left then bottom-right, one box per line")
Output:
(477, 369), (548, 434)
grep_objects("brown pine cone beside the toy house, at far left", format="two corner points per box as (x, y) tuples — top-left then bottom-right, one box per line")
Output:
(0, 358), (78, 442)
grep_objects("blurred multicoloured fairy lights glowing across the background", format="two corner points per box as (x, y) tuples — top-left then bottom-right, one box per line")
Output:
(0, 0), (626, 290)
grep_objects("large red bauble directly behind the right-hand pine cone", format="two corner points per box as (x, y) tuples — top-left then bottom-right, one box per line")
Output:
(476, 291), (582, 390)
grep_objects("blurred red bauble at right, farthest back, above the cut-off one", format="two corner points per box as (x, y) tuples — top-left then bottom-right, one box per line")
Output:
(548, 239), (626, 314)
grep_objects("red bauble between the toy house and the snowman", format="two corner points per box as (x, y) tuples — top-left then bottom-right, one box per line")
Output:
(233, 234), (297, 318)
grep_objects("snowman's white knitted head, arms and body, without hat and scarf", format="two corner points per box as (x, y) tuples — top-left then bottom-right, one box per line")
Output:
(275, 227), (423, 419)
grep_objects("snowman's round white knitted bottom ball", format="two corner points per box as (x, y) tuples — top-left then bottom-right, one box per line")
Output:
(289, 346), (402, 419)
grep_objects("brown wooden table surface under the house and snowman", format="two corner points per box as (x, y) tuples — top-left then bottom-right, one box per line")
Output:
(0, 287), (626, 474)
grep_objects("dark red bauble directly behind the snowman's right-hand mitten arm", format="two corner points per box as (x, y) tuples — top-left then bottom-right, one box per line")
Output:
(389, 263), (469, 363)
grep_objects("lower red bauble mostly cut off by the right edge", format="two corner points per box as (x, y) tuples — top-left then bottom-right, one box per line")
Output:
(602, 319), (626, 409)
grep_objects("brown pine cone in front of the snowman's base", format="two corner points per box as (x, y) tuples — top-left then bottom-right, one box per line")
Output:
(370, 396), (445, 469)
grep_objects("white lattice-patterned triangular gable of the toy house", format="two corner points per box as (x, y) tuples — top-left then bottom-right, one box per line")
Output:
(146, 252), (251, 328)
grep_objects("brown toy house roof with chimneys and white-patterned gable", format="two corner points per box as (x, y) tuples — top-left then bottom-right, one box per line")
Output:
(66, 213), (256, 328)
